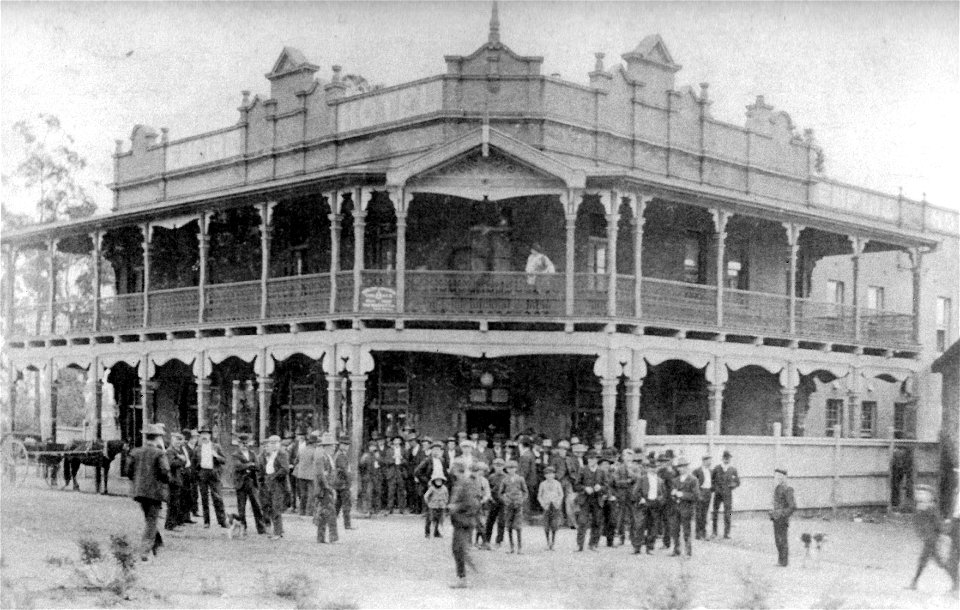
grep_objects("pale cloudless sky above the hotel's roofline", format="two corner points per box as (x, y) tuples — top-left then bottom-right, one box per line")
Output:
(0, 1), (960, 220)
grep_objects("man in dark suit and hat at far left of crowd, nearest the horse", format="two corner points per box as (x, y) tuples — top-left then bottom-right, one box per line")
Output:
(124, 424), (170, 561)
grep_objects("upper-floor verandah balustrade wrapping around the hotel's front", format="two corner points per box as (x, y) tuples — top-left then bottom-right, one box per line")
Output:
(11, 269), (913, 346)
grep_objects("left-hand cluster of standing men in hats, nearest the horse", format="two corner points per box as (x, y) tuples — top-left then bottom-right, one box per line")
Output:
(123, 424), (351, 561)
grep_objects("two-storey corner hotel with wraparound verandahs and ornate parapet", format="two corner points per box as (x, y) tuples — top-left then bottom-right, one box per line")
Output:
(3, 4), (960, 508)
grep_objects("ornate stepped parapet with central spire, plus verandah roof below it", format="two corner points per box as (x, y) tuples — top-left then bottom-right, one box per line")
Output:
(101, 29), (960, 236)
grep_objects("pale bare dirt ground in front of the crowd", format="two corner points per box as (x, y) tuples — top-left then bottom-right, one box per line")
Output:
(0, 470), (958, 608)
